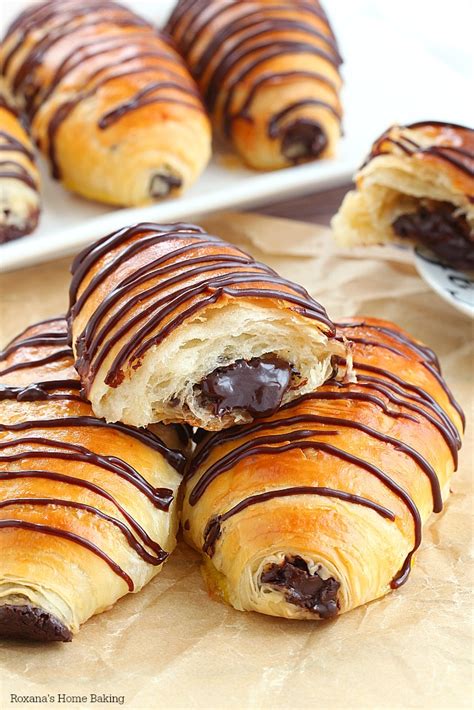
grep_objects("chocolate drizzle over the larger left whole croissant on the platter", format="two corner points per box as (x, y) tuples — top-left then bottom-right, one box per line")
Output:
(2, 0), (203, 178)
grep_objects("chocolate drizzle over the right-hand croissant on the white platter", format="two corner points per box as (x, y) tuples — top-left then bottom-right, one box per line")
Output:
(167, 0), (342, 149)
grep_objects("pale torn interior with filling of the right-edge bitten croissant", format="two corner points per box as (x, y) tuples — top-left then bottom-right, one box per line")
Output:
(332, 146), (474, 270)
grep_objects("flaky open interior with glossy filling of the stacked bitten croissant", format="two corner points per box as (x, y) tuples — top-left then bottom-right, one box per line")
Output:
(91, 302), (345, 430)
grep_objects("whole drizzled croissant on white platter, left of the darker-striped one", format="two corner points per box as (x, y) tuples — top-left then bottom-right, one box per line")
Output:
(0, 0), (210, 205)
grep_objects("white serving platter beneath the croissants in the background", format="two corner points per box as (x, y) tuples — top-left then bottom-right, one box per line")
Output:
(0, 0), (471, 271)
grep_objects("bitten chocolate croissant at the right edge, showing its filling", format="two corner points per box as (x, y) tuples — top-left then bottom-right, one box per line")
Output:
(332, 121), (474, 270)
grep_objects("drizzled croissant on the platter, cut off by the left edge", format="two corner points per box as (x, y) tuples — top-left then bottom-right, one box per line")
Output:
(0, 80), (40, 244)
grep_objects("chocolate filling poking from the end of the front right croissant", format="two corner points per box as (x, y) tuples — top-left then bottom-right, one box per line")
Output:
(260, 555), (341, 619)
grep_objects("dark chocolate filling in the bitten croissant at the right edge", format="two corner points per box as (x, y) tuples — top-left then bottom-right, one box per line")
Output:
(392, 202), (474, 276)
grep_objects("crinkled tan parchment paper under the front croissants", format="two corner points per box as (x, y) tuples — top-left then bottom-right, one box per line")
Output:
(0, 214), (474, 710)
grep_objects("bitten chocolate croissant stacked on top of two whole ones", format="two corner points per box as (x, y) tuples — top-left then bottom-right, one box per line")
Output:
(69, 224), (350, 430)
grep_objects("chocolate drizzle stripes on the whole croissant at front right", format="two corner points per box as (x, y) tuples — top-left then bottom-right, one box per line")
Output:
(186, 320), (464, 588)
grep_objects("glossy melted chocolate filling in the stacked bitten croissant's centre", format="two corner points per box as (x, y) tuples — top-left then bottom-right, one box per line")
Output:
(201, 355), (293, 417)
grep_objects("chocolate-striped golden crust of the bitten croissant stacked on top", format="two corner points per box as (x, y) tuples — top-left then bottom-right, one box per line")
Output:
(69, 224), (333, 392)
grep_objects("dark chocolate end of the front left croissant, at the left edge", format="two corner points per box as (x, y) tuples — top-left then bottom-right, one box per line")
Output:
(0, 604), (72, 641)
